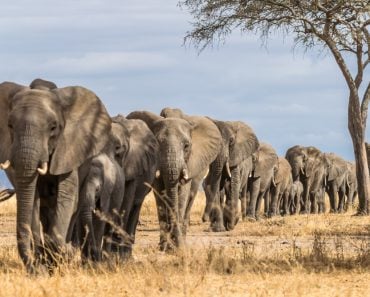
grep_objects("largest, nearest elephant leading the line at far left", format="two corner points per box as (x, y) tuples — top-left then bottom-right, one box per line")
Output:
(0, 82), (111, 273)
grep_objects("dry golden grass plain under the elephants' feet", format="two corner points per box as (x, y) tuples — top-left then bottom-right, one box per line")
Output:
(0, 193), (370, 296)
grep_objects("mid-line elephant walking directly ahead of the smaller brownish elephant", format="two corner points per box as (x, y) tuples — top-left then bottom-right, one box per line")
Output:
(246, 143), (279, 221)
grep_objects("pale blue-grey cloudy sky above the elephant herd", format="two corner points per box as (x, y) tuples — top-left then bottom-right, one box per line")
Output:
(0, 0), (370, 183)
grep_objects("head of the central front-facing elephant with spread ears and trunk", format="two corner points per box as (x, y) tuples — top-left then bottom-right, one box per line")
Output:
(127, 111), (221, 246)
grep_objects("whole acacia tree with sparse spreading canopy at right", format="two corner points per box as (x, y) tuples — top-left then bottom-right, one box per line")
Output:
(180, 0), (370, 214)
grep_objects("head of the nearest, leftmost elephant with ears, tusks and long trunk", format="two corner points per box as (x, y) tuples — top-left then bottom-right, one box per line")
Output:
(0, 82), (111, 265)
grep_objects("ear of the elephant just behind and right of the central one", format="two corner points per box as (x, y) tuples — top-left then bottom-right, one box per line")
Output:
(226, 121), (259, 167)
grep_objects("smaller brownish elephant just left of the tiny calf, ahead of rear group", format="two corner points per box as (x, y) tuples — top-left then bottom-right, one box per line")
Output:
(269, 157), (293, 216)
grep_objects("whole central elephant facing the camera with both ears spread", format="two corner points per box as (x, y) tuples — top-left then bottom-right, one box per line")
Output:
(127, 111), (222, 250)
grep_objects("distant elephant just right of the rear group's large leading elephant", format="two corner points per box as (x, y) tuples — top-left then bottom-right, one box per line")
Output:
(325, 153), (349, 213)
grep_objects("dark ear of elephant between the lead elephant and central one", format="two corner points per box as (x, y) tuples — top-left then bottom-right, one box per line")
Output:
(113, 117), (159, 180)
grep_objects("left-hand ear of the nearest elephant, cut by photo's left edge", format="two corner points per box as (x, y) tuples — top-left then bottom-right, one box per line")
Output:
(0, 82), (25, 163)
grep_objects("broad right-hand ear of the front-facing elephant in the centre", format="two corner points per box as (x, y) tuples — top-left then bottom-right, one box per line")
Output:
(187, 116), (222, 178)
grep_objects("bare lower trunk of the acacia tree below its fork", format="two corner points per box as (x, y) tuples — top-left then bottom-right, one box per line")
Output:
(348, 91), (370, 214)
